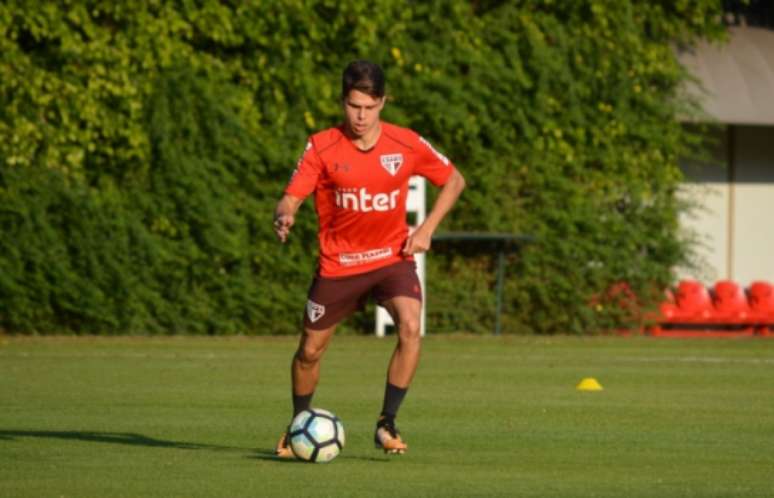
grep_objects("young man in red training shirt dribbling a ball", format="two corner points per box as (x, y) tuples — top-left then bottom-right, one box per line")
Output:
(274, 61), (465, 457)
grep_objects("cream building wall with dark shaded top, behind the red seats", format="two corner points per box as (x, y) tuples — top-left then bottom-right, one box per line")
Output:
(676, 126), (774, 286)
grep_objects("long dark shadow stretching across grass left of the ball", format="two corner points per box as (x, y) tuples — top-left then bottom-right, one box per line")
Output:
(0, 430), (251, 451)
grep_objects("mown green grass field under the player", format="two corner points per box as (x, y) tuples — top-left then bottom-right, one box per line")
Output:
(0, 336), (774, 498)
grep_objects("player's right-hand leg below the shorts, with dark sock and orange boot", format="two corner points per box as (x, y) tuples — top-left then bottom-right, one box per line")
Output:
(374, 296), (422, 453)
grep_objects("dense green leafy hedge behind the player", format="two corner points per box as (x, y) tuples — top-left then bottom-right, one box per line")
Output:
(0, 0), (723, 333)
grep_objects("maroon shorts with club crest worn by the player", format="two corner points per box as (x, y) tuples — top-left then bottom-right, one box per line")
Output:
(304, 261), (422, 330)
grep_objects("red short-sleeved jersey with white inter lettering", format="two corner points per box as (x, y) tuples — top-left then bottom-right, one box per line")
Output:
(285, 122), (454, 277)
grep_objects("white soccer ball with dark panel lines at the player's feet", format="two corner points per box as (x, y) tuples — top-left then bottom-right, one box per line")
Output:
(289, 408), (345, 463)
